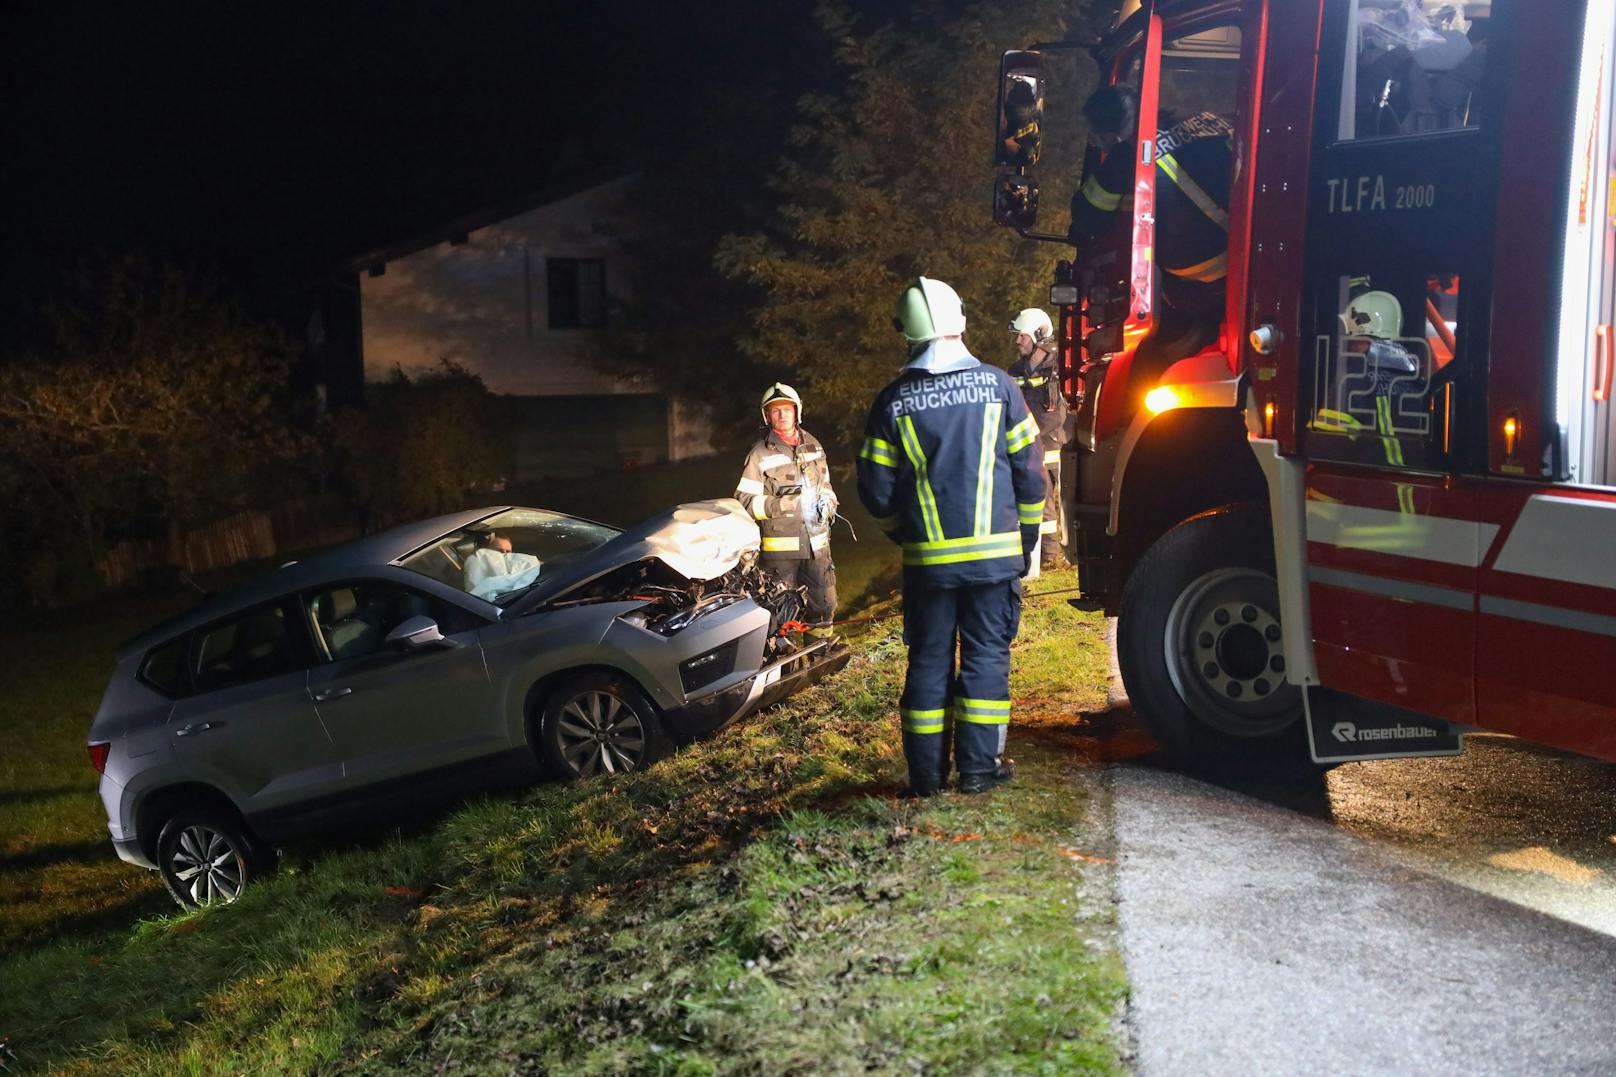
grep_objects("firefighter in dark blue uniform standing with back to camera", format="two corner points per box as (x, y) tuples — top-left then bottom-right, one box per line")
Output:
(858, 277), (1044, 796)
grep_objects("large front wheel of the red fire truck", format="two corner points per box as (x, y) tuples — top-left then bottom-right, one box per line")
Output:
(1117, 509), (1314, 773)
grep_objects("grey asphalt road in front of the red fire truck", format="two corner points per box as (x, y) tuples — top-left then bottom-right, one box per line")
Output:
(1109, 734), (1616, 1077)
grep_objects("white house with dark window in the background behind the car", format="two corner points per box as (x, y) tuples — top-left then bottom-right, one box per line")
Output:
(357, 178), (713, 480)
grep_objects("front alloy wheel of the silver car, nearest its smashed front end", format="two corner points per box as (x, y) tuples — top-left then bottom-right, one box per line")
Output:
(538, 673), (667, 779)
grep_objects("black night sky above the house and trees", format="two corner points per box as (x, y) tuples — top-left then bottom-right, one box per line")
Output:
(0, 0), (814, 336)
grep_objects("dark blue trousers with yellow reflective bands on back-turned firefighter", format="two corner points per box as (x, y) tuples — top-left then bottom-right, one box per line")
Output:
(898, 579), (1021, 788)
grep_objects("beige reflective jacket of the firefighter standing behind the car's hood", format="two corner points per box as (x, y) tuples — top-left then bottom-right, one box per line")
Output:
(735, 427), (835, 561)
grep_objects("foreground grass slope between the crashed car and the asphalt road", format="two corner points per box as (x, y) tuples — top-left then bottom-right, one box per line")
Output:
(0, 574), (1123, 1074)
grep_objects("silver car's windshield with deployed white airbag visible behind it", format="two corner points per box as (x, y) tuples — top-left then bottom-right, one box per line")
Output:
(399, 508), (621, 605)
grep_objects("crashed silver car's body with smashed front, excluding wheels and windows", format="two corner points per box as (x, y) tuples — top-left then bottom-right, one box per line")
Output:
(89, 500), (845, 867)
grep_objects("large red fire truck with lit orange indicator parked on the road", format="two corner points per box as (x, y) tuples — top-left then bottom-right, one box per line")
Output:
(995, 0), (1616, 765)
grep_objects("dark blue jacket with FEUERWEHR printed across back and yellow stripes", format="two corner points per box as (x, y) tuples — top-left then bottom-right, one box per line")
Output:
(858, 356), (1044, 587)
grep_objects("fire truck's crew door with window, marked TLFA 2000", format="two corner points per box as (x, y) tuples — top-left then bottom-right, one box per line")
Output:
(1279, 0), (1496, 724)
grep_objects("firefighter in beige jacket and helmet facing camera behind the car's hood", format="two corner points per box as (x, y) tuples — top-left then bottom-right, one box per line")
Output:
(735, 382), (837, 624)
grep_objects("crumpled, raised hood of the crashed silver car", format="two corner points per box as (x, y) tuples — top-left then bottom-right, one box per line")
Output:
(511, 498), (763, 615)
